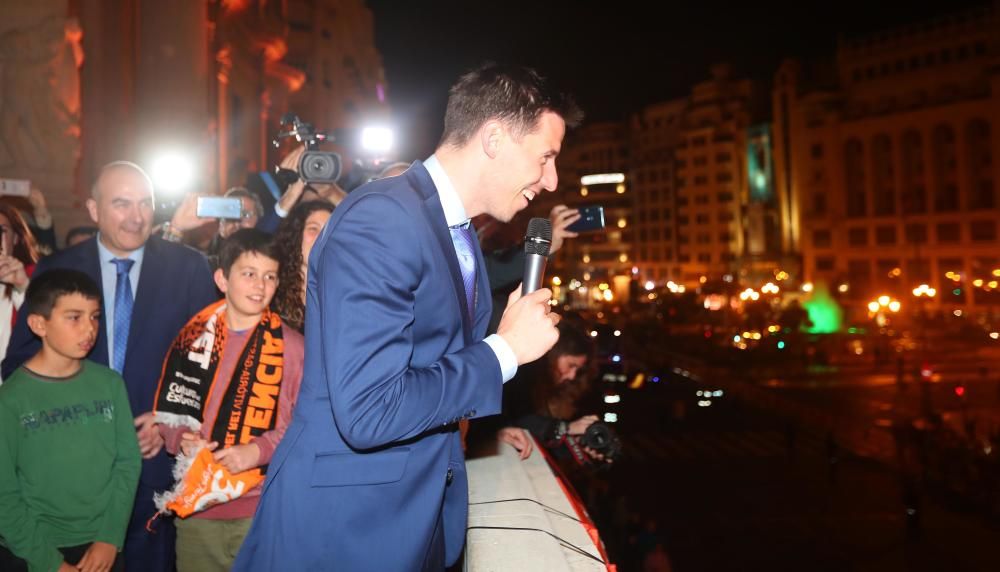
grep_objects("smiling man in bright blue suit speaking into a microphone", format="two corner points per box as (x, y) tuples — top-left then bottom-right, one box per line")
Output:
(234, 65), (580, 572)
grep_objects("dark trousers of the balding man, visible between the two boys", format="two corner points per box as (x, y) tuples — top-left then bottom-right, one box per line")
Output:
(127, 482), (177, 572)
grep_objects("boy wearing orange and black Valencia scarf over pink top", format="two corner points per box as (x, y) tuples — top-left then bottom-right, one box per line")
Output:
(154, 229), (304, 572)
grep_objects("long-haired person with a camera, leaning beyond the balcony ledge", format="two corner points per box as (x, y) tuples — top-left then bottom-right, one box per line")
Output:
(504, 320), (616, 466)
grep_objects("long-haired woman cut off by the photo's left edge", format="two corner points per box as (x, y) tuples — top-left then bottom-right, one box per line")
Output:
(0, 203), (38, 381)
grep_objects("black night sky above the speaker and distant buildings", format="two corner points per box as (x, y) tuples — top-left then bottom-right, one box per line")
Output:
(368, 0), (984, 160)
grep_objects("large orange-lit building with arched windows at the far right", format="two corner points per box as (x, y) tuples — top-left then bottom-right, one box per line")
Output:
(773, 5), (1000, 308)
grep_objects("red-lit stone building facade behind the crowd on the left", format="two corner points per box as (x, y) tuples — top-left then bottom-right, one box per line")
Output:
(0, 0), (385, 236)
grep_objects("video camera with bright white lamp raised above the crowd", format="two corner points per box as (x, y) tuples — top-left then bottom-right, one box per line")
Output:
(271, 113), (392, 192)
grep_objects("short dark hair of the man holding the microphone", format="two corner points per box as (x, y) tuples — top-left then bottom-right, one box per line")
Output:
(441, 63), (583, 147)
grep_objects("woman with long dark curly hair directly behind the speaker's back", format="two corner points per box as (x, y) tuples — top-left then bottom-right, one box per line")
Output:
(274, 201), (333, 332)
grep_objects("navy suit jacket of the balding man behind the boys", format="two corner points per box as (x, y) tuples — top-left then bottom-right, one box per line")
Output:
(3, 237), (218, 484)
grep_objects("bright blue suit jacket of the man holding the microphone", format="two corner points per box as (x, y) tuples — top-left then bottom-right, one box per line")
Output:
(234, 163), (503, 571)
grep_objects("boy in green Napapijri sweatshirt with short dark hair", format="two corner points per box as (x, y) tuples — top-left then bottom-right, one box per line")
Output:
(0, 270), (141, 572)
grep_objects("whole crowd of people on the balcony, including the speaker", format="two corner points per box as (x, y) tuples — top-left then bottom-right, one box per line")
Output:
(0, 65), (612, 572)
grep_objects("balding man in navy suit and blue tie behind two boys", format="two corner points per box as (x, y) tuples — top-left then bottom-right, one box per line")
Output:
(3, 161), (217, 572)
